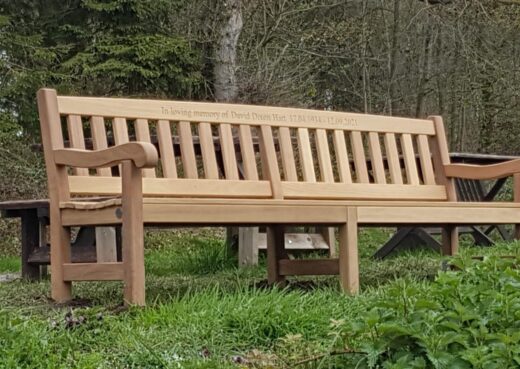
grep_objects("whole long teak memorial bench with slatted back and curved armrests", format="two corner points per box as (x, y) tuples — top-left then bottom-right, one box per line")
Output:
(38, 89), (520, 305)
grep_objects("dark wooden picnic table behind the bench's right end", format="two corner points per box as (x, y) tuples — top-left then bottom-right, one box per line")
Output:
(374, 152), (519, 259)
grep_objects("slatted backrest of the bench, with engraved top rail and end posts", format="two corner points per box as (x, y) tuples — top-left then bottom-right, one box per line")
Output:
(38, 89), (456, 200)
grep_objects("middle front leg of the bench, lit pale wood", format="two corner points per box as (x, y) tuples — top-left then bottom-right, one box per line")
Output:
(339, 208), (359, 295)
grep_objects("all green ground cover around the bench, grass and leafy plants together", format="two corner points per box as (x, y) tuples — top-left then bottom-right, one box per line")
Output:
(0, 230), (520, 369)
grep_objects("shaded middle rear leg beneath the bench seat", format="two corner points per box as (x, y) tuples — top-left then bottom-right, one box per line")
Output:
(267, 225), (287, 285)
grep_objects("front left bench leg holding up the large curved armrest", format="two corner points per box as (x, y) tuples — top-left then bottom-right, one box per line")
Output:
(122, 161), (145, 306)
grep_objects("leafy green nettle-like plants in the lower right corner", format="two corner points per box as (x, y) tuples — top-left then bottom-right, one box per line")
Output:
(333, 257), (520, 369)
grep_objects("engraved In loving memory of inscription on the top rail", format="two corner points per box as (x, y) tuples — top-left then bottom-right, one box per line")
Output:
(161, 106), (358, 127)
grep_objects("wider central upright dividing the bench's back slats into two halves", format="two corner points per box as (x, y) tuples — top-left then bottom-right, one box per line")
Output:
(259, 125), (283, 199)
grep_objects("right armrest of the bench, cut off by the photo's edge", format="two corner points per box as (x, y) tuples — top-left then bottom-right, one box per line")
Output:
(444, 159), (520, 179)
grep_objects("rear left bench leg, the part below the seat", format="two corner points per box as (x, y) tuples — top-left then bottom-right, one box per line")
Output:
(50, 217), (72, 303)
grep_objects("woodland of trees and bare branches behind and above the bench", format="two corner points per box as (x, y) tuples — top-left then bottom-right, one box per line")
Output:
(0, 0), (520, 199)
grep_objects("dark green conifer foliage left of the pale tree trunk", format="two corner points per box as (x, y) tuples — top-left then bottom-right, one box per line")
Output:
(0, 0), (202, 135)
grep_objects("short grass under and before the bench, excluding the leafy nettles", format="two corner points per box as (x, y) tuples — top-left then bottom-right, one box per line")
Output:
(0, 230), (518, 369)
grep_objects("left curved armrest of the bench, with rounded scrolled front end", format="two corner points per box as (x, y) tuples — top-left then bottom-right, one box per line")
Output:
(54, 142), (159, 168)
